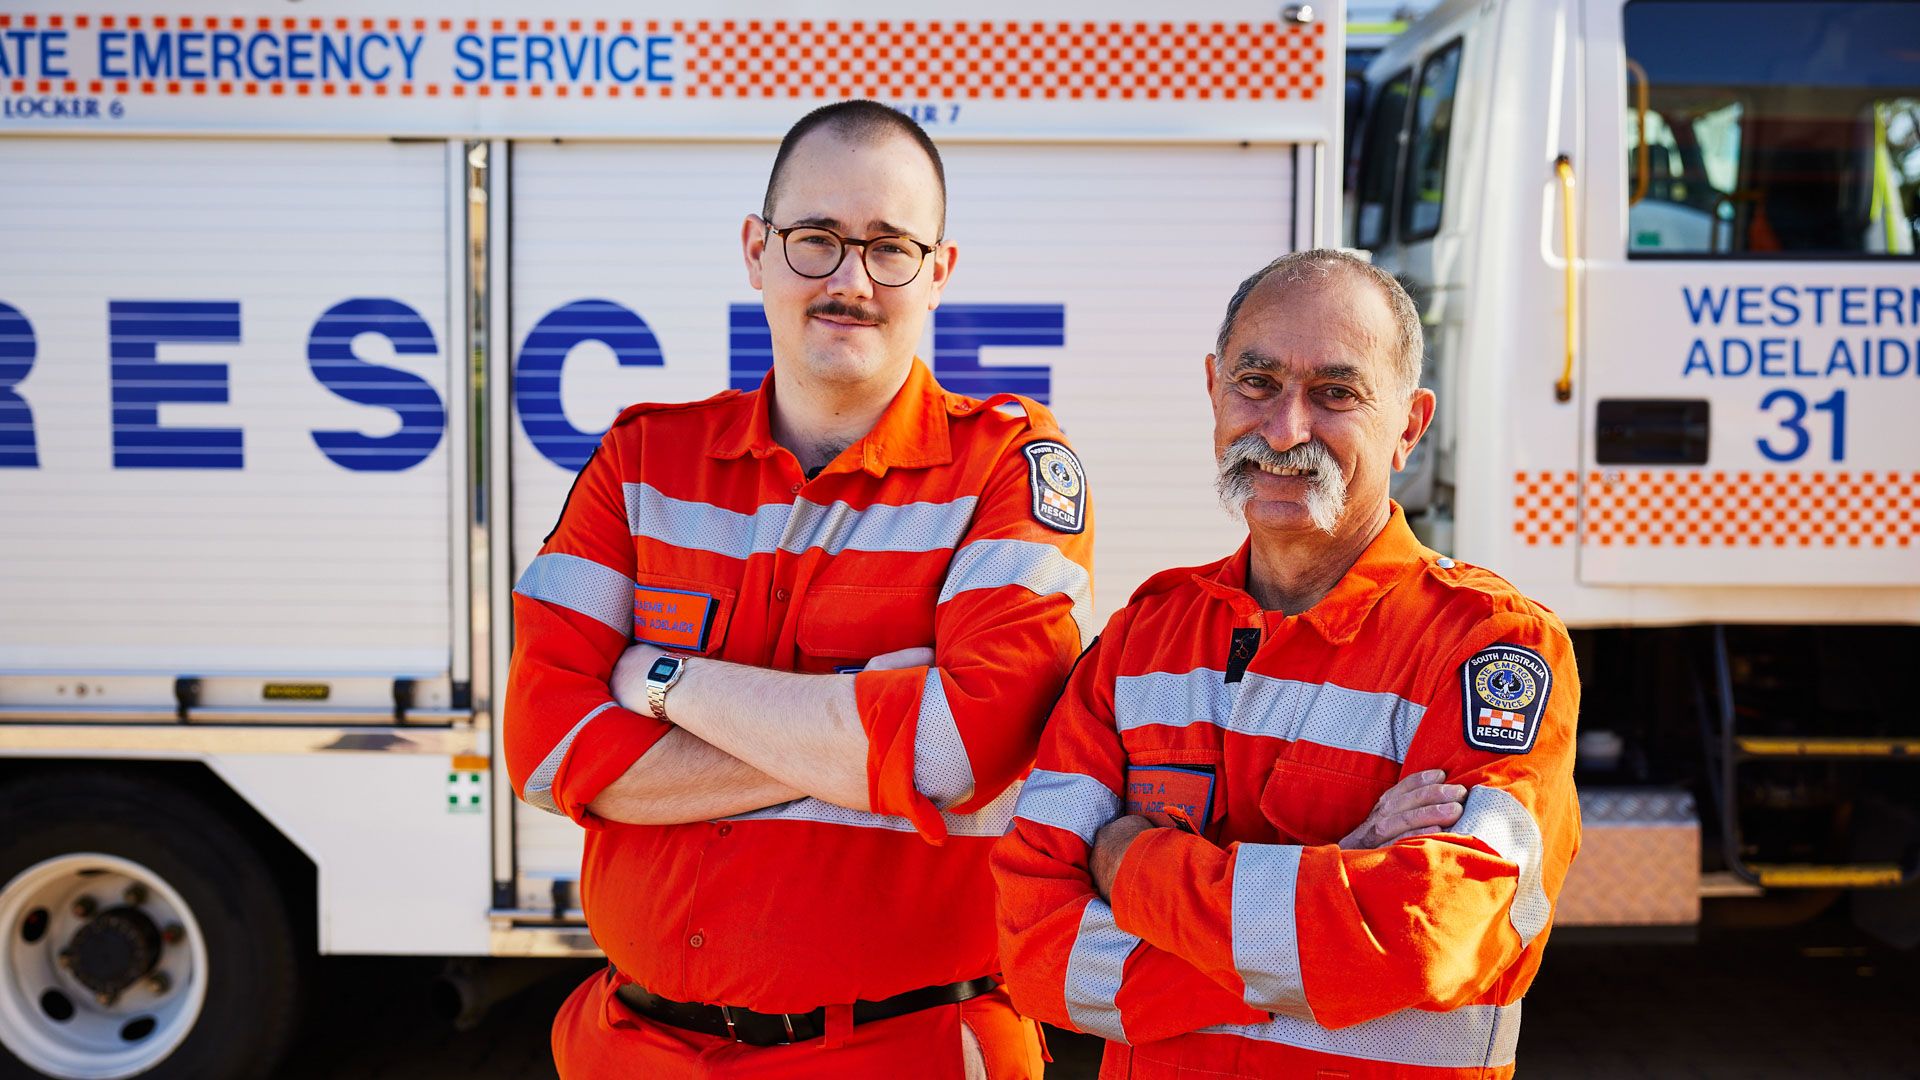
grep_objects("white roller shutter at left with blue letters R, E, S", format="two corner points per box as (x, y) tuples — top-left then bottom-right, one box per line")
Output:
(0, 138), (453, 676)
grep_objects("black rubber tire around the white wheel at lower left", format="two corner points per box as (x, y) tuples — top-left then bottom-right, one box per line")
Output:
(0, 771), (301, 1080)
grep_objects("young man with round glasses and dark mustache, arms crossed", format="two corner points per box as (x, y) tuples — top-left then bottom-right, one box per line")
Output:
(507, 102), (1091, 1080)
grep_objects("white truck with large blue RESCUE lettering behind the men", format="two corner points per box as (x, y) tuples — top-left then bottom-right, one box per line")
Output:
(0, 0), (1342, 1078)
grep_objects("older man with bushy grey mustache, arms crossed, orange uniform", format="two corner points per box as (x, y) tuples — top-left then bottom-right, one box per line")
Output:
(993, 250), (1580, 1080)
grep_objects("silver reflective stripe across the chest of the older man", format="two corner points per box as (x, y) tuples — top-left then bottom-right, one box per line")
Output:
(1114, 667), (1427, 763)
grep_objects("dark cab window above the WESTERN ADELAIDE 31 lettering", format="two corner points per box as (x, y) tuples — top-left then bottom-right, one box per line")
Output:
(1624, 0), (1920, 259)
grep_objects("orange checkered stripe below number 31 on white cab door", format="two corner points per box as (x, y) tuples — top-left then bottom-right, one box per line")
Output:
(1513, 469), (1920, 548)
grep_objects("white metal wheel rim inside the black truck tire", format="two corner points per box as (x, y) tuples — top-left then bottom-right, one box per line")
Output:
(0, 853), (207, 1080)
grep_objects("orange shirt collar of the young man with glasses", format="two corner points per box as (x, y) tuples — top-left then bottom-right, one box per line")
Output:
(707, 357), (954, 477)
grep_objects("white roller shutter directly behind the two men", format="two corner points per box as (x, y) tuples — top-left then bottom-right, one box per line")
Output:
(511, 136), (1296, 891)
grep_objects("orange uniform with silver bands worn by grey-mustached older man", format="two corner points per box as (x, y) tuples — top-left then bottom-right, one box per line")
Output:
(993, 507), (1580, 1080)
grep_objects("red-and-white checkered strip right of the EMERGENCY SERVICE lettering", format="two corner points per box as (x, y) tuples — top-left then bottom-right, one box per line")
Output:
(672, 21), (1325, 100)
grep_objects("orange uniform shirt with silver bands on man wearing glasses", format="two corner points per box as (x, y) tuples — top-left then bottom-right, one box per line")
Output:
(507, 359), (1091, 1074)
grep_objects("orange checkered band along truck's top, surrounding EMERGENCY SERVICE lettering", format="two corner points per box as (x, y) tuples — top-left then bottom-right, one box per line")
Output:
(0, 13), (1327, 102)
